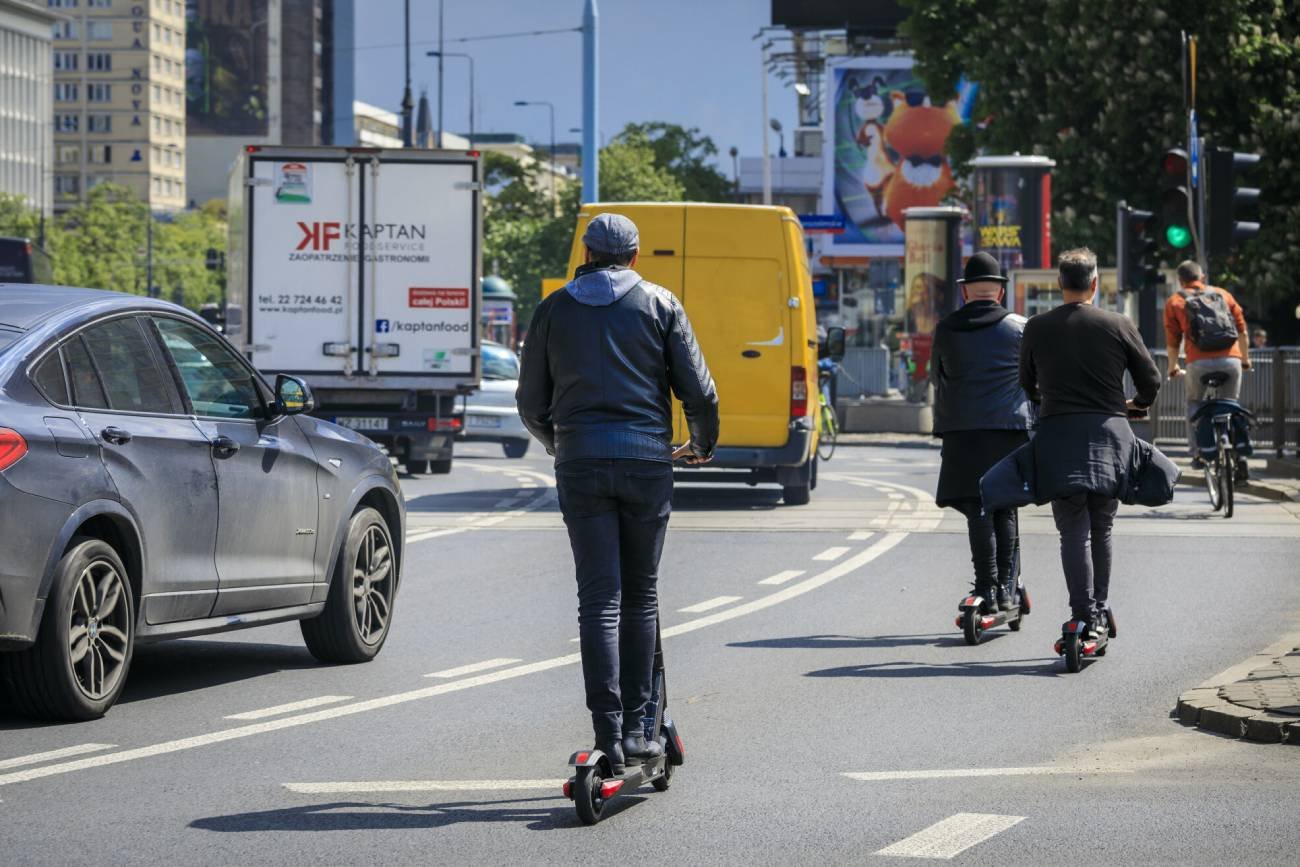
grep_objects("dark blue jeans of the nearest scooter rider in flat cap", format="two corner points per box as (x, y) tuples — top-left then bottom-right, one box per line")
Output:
(555, 460), (672, 740)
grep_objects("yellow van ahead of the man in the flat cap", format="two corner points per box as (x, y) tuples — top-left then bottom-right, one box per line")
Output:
(553, 203), (818, 506)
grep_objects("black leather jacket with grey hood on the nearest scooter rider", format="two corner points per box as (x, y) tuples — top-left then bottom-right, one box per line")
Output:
(515, 265), (718, 465)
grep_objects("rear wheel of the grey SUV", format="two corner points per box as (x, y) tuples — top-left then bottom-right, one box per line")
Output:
(0, 537), (135, 720)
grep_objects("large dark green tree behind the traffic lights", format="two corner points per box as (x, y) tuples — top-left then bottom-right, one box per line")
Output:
(905, 0), (1300, 306)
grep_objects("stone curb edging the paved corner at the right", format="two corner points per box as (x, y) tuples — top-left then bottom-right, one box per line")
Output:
(1173, 632), (1300, 746)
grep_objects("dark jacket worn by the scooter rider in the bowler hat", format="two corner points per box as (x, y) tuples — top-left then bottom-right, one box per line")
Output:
(930, 300), (1032, 435)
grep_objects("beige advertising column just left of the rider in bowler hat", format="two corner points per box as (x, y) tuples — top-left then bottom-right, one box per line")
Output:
(898, 207), (969, 402)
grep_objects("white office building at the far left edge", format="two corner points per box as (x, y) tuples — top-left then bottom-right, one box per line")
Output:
(0, 0), (59, 213)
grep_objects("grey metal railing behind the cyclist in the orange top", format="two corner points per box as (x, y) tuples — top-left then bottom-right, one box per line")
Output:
(1130, 346), (1300, 456)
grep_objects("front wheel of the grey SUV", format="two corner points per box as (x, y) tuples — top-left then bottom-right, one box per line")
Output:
(298, 507), (398, 663)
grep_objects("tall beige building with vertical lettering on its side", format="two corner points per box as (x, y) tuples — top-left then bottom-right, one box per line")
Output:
(48, 0), (186, 211)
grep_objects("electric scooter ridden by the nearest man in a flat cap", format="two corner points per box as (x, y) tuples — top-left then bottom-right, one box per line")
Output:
(564, 623), (686, 825)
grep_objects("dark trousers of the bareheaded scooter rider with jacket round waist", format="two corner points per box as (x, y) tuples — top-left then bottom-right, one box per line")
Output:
(1052, 494), (1119, 620)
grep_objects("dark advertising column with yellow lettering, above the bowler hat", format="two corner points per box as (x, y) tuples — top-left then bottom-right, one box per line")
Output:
(970, 155), (1056, 313)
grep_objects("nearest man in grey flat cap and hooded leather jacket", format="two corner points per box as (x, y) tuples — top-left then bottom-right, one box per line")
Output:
(515, 213), (719, 773)
